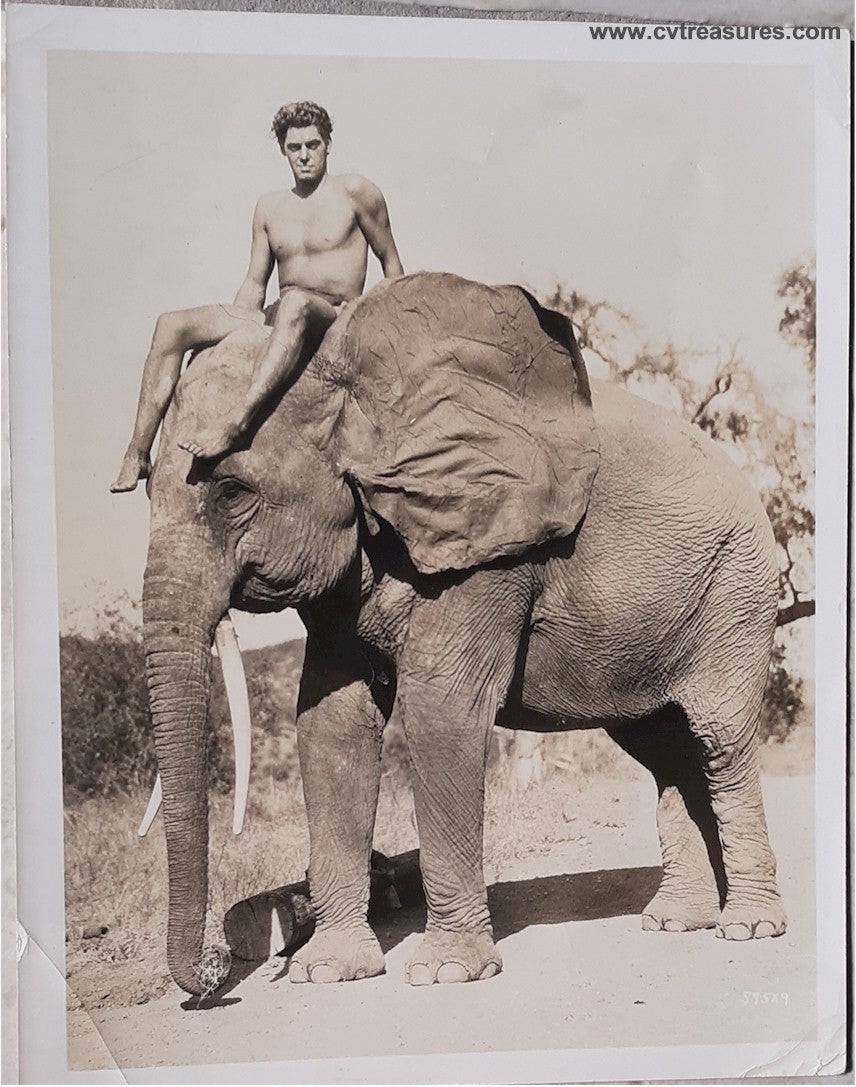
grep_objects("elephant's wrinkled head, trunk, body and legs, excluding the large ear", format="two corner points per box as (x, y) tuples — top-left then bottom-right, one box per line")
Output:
(144, 273), (785, 992)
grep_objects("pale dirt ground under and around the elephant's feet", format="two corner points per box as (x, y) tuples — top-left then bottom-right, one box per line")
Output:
(69, 776), (817, 1082)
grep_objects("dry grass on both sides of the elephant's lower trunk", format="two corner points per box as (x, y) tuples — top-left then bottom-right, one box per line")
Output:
(65, 783), (309, 1007)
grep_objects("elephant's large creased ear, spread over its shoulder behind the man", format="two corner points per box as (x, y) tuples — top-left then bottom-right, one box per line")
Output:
(314, 273), (598, 573)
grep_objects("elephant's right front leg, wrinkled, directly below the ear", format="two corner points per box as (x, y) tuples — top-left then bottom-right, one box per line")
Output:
(398, 571), (529, 985)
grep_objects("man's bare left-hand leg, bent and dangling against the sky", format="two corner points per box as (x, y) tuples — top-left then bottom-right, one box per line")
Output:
(110, 305), (264, 493)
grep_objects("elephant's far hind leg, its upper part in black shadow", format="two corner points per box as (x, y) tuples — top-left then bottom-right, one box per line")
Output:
(608, 705), (725, 933)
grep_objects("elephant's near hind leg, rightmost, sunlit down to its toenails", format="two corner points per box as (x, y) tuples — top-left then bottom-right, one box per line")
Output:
(682, 675), (786, 940)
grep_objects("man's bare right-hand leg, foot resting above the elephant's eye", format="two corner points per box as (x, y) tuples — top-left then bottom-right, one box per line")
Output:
(178, 288), (338, 458)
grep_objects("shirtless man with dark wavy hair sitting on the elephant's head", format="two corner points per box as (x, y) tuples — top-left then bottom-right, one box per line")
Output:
(110, 102), (404, 491)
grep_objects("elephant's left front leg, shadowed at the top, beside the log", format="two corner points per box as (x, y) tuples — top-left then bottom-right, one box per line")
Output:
(288, 640), (386, 982)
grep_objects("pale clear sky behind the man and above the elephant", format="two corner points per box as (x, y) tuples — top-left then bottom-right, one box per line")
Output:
(48, 52), (815, 644)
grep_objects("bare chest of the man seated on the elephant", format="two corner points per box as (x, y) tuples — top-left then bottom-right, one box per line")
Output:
(268, 193), (359, 260)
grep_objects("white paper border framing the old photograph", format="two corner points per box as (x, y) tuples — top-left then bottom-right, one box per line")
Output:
(7, 4), (851, 1083)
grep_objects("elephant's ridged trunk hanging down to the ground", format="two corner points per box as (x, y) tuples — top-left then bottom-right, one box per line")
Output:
(142, 539), (228, 995)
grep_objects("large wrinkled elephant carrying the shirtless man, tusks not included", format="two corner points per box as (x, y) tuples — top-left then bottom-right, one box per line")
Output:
(142, 273), (785, 994)
